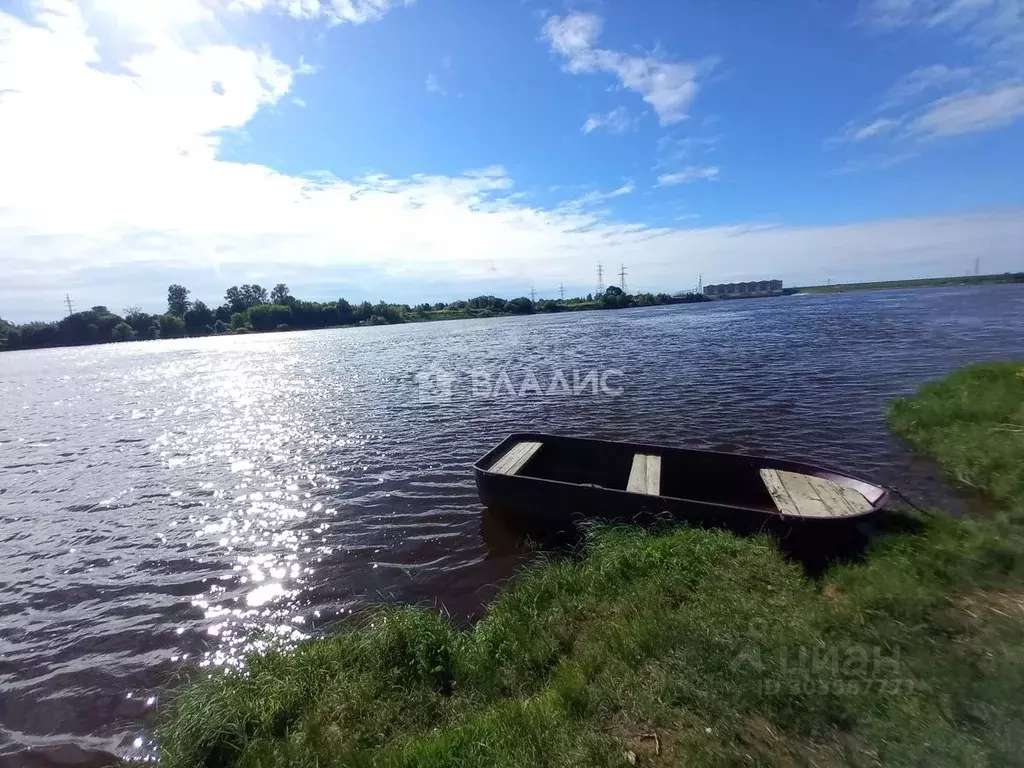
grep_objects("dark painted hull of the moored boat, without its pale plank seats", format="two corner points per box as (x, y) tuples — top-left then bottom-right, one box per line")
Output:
(473, 432), (889, 531)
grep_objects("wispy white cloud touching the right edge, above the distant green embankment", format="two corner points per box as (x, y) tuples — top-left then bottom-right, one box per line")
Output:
(909, 83), (1024, 138)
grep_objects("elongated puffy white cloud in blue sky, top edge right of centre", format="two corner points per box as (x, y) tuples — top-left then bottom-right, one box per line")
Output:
(543, 12), (708, 125)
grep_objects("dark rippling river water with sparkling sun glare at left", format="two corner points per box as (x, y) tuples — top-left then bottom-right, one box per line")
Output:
(0, 286), (1024, 765)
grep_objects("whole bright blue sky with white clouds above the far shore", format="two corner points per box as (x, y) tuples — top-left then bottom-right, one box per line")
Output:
(0, 0), (1024, 322)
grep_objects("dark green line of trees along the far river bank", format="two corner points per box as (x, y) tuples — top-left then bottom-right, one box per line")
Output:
(0, 283), (705, 351)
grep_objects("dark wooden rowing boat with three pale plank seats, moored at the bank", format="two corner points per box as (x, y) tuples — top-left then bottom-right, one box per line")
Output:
(473, 433), (889, 531)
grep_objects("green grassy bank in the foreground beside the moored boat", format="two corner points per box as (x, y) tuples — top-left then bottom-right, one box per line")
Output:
(158, 365), (1024, 767)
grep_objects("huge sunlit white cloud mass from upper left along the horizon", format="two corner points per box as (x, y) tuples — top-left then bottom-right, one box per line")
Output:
(0, 0), (1024, 321)
